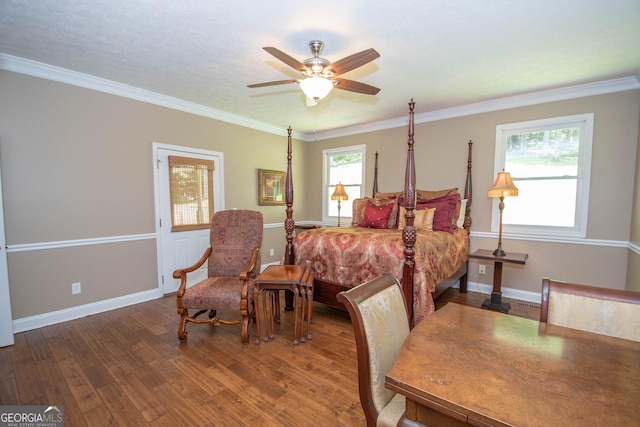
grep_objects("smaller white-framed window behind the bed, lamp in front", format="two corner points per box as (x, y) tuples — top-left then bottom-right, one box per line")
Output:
(322, 145), (365, 221)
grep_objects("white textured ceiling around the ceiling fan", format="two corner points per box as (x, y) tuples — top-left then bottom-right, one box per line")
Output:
(0, 0), (640, 140)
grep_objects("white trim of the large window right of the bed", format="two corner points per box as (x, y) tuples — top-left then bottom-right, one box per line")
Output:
(491, 113), (594, 238)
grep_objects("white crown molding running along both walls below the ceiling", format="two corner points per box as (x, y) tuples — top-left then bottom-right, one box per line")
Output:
(0, 53), (640, 142)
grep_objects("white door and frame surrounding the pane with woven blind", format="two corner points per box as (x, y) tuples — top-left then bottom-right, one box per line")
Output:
(153, 143), (224, 294)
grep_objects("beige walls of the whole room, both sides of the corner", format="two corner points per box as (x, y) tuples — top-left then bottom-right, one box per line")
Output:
(0, 71), (640, 319)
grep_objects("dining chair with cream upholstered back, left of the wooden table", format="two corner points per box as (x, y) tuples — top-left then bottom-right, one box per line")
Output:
(337, 273), (409, 427)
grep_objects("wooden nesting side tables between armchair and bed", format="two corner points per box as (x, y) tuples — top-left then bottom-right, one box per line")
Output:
(253, 265), (313, 345)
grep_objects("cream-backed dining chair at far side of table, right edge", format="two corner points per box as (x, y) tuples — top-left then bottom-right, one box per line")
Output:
(540, 277), (640, 342)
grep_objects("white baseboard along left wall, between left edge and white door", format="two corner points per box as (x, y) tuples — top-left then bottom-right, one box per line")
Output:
(13, 289), (163, 334)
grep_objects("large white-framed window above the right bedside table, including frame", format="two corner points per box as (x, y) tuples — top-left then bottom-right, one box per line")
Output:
(491, 114), (593, 238)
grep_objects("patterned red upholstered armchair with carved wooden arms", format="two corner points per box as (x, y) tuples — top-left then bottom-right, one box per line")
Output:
(173, 210), (263, 343)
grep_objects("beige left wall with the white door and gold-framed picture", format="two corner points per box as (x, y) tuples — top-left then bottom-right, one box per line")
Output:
(0, 71), (306, 320)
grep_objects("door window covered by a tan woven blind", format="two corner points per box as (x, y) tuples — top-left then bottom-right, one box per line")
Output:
(169, 156), (214, 232)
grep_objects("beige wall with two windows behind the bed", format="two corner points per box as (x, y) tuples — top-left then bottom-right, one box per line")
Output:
(307, 91), (640, 293)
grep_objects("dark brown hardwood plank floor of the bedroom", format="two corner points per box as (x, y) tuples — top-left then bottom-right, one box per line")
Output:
(0, 289), (539, 427)
